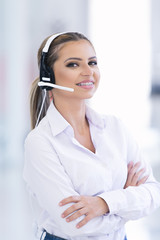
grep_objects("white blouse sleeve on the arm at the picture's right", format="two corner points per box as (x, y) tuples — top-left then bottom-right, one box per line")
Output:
(100, 122), (160, 220)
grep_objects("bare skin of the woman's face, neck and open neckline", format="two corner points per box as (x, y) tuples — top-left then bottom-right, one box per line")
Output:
(52, 40), (100, 152)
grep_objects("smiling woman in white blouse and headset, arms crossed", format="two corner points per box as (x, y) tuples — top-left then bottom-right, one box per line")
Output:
(24, 32), (160, 240)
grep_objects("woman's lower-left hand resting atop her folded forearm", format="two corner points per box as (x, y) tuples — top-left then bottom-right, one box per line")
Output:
(59, 196), (109, 228)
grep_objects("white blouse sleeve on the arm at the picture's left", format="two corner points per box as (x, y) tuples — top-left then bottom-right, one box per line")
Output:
(24, 134), (125, 237)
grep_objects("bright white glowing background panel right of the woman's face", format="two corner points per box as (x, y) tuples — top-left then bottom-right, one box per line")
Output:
(89, 0), (151, 135)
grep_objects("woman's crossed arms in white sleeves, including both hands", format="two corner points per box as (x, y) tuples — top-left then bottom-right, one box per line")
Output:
(23, 131), (160, 237)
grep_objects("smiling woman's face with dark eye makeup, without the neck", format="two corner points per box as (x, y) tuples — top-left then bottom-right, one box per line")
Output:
(53, 40), (100, 99)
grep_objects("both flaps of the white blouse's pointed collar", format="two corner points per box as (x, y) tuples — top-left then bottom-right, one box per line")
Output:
(46, 102), (105, 136)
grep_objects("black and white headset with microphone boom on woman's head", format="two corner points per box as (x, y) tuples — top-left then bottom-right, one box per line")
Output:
(38, 32), (74, 92)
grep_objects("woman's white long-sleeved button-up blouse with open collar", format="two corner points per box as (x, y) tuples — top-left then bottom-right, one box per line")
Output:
(24, 103), (160, 240)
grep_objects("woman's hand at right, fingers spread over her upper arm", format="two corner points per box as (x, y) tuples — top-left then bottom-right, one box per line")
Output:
(124, 162), (148, 188)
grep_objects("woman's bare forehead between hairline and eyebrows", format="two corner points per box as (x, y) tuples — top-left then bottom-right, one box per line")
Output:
(58, 40), (95, 58)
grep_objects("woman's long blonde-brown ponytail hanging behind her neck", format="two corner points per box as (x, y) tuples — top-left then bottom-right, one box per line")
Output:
(30, 78), (50, 129)
